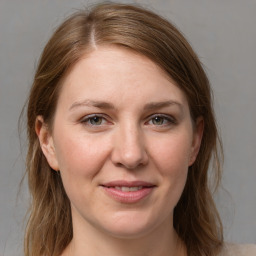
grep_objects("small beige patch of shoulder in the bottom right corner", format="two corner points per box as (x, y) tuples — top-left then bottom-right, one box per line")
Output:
(220, 243), (256, 256)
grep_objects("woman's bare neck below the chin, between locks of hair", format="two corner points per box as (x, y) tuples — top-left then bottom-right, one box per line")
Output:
(62, 214), (186, 256)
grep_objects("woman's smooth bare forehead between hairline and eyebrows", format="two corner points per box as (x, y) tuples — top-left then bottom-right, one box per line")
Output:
(59, 47), (186, 109)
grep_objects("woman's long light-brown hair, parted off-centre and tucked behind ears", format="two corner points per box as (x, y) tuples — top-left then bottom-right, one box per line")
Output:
(24, 3), (223, 256)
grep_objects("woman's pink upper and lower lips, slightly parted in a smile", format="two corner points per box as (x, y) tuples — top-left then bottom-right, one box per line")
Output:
(101, 180), (156, 204)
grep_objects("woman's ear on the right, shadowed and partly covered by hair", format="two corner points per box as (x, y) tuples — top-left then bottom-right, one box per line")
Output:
(189, 116), (204, 166)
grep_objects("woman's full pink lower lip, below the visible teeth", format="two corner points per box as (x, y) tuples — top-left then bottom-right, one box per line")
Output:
(103, 187), (154, 203)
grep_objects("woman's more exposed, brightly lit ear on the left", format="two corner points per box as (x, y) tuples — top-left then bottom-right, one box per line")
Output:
(35, 116), (59, 171)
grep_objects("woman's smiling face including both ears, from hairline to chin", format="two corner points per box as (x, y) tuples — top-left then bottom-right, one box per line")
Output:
(36, 47), (202, 240)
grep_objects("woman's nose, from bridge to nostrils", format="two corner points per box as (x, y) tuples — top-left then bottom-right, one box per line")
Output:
(111, 122), (148, 169)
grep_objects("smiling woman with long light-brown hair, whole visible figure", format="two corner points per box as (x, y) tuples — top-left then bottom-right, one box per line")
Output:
(25, 4), (255, 256)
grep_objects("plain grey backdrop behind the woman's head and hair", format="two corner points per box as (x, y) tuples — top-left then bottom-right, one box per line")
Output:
(0, 0), (256, 256)
